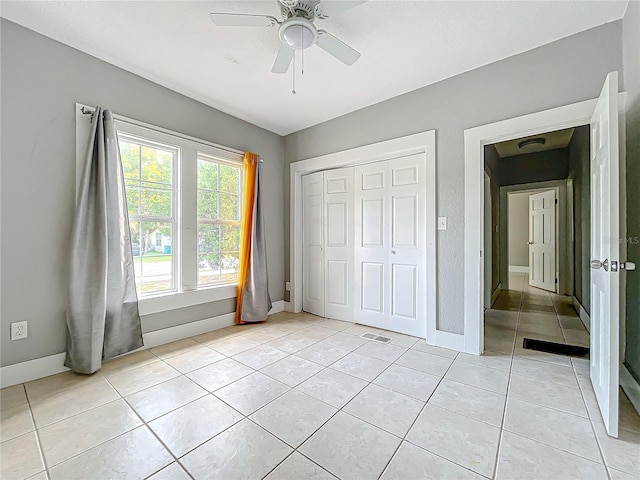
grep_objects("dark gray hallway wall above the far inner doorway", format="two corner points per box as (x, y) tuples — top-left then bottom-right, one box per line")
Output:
(498, 148), (569, 187)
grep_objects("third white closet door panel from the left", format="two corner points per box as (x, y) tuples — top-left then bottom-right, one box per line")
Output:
(354, 162), (390, 330)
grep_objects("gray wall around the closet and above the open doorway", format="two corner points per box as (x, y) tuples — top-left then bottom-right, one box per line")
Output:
(284, 21), (622, 333)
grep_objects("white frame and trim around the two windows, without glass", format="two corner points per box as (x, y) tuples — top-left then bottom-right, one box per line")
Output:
(76, 103), (243, 315)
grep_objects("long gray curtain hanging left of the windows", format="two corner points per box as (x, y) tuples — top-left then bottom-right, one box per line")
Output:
(65, 107), (143, 373)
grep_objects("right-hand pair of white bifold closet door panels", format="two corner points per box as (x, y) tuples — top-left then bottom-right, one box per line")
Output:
(354, 154), (427, 338)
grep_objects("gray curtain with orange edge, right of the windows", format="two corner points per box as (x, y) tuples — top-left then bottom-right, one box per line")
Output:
(240, 161), (271, 322)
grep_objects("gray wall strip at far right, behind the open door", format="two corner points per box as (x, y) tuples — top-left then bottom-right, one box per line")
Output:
(622, 1), (640, 382)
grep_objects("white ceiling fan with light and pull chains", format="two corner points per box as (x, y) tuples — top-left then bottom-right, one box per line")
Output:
(211, 0), (367, 73)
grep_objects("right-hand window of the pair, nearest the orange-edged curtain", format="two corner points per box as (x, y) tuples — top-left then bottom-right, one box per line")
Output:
(198, 153), (240, 286)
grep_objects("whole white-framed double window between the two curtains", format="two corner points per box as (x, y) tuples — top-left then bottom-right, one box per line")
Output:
(109, 119), (242, 314)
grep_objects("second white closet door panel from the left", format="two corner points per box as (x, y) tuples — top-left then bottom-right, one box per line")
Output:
(324, 167), (354, 321)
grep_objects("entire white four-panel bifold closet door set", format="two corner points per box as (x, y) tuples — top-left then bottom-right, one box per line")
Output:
(302, 154), (426, 338)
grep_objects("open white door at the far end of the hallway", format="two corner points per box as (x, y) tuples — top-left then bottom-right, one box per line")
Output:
(529, 190), (556, 292)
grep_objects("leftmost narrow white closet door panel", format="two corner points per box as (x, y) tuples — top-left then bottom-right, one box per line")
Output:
(302, 172), (325, 317)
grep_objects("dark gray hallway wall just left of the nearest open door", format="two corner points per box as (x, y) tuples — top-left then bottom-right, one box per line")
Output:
(569, 125), (591, 313)
